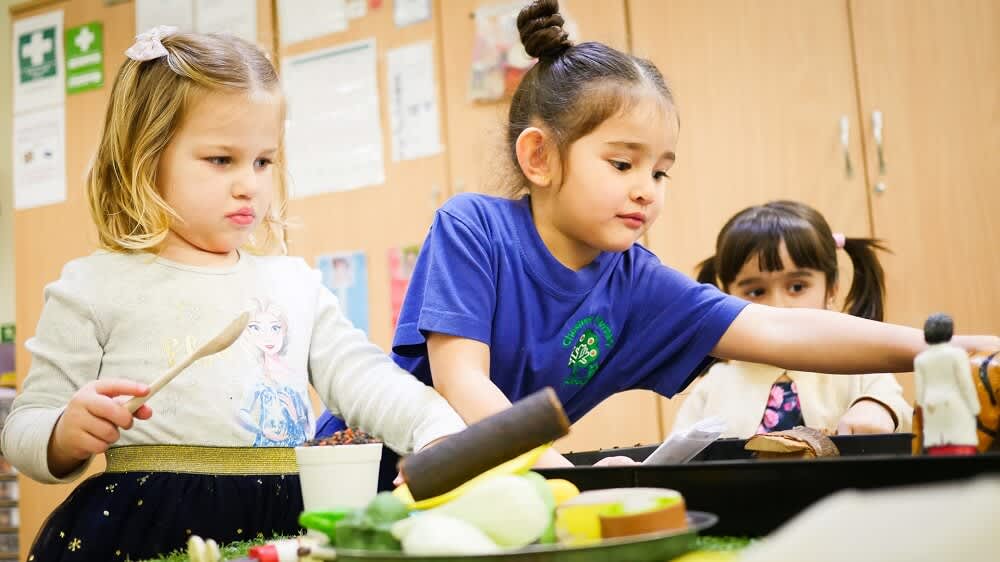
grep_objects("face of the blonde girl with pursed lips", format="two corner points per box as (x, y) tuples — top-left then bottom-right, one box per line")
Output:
(156, 93), (282, 265)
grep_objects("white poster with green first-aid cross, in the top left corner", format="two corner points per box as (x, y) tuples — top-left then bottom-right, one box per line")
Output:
(11, 10), (66, 114)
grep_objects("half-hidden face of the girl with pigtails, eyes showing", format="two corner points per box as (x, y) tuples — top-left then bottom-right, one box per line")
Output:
(728, 242), (833, 309)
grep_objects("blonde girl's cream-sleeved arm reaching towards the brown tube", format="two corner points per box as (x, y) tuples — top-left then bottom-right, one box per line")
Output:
(309, 278), (465, 454)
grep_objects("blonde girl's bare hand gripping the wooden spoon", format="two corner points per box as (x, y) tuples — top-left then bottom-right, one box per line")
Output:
(48, 380), (153, 477)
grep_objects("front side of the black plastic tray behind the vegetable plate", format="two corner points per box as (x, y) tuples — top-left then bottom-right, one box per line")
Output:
(538, 449), (1000, 536)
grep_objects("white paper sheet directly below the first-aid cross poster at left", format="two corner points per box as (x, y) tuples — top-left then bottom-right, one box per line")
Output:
(13, 106), (66, 209)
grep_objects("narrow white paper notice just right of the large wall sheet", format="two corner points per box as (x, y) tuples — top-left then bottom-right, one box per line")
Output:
(386, 41), (441, 161)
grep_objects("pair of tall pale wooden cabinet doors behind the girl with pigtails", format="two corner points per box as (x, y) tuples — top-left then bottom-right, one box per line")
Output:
(628, 0), (1000, 433)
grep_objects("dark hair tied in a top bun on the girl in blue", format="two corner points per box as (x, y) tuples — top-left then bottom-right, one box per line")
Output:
(507, 0), (674, 193)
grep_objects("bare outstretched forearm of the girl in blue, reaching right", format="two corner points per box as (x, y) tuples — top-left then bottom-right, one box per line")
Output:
(712, 304), (1000, 374)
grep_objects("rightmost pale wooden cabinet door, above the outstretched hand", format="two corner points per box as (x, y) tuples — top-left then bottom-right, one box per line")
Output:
(850, 0), (1000, 334)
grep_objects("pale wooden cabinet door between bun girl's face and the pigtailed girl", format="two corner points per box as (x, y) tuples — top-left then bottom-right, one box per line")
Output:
(629, 0), (871, 280)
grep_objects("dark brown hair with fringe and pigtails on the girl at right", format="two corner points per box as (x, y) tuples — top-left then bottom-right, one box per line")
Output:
(698, 201), (888, 321)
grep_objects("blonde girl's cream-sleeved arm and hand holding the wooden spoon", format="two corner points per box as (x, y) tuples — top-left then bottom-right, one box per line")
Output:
(0, 263), (151, 483)
